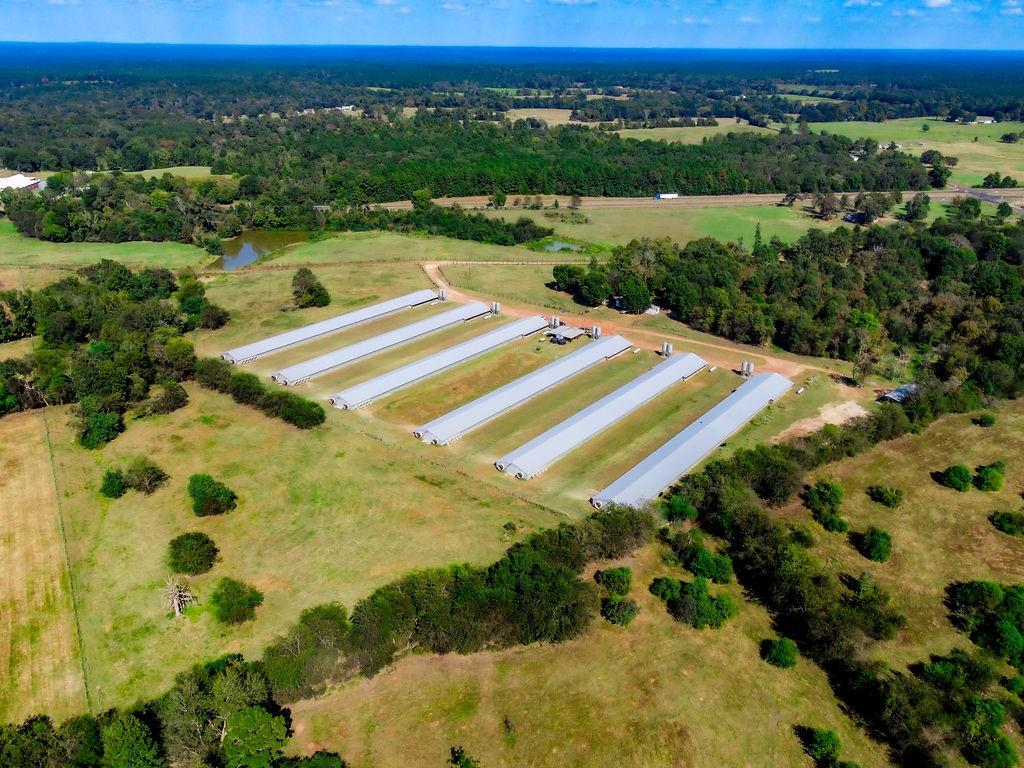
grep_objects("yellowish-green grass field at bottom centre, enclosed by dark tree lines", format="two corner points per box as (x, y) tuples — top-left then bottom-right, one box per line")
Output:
(289, 546), (889, 768)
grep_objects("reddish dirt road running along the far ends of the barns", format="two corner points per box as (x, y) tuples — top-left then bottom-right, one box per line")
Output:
(420, 261), (842, 381)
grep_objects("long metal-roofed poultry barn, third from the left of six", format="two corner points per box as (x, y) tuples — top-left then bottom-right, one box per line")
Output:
(330, 314), (548, 411)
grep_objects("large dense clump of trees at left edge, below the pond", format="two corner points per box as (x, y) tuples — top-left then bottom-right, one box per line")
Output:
(0, 259), (205, 449)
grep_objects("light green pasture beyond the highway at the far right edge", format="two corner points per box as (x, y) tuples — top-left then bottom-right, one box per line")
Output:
(809, 118), (1024, 186)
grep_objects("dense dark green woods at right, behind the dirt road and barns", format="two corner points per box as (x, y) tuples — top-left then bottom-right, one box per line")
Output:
(554, 204), (1024, 397)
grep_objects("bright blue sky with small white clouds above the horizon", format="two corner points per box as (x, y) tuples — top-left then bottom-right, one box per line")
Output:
(0, 0), (1024, 49)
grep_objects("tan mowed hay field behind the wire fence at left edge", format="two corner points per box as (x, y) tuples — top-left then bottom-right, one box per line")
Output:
(0, 413), (86, 722)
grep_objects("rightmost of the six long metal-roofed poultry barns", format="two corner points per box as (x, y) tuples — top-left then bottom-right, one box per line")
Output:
(590, 374), (793, 509)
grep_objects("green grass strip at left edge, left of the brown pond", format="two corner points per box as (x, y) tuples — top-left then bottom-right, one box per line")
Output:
(0, 218), (210, 269)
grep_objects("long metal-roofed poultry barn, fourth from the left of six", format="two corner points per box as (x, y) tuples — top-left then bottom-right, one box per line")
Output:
(413, 336), (632, 445)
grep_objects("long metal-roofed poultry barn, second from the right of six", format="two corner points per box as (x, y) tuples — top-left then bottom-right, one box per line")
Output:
(495, 353), (708, 480)
